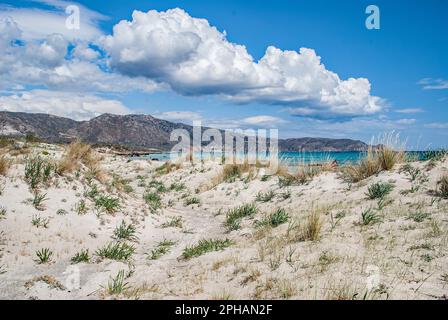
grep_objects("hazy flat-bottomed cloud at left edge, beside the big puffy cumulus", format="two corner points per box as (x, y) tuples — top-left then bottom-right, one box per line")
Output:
(0, 17), (157, 92)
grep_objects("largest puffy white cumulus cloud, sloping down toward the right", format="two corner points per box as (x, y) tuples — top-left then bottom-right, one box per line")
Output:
(102, 9), (384, 116)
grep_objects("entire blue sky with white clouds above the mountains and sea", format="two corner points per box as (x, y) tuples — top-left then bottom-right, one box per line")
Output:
(0, 0), (448, 149)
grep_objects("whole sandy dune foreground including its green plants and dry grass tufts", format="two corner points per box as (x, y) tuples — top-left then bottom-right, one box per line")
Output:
(0, 141), (448, 300)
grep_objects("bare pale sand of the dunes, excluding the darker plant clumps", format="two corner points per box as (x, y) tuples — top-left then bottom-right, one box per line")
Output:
(0, 144), (448, 299)
